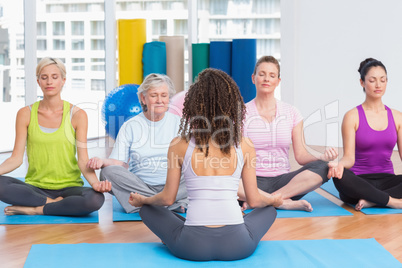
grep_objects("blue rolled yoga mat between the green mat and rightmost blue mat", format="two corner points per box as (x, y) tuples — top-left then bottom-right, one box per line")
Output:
(209, 41), (232, 75)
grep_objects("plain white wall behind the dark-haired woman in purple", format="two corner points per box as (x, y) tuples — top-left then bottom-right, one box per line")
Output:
(281, 0), (402, 146)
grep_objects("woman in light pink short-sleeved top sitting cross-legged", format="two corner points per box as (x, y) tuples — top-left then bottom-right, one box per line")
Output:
(239, 56), (338, 211)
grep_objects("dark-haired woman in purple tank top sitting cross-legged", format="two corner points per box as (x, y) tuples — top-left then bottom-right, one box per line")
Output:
(328, 58), (402, 210)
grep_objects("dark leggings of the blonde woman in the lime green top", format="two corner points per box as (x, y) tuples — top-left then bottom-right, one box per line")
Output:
(0, 176), (105, 216)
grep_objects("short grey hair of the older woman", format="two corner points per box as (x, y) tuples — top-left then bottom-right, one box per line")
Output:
(137, 73), (176, 111)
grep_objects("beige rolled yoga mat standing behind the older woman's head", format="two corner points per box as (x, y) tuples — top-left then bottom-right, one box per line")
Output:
(159, 36), (184, 92)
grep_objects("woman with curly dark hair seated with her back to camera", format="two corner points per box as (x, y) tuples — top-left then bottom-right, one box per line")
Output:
(129, 69), (282, 261)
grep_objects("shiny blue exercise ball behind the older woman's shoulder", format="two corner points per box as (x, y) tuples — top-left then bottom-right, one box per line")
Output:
(102, 84), (142, 139)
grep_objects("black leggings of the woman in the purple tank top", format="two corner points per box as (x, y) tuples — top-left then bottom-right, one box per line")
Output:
(333, 169), (402, 207)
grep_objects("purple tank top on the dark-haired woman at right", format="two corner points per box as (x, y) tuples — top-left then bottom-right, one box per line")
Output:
(350, 105), (397, 175)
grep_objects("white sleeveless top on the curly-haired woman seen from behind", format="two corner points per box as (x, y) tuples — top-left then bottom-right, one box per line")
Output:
(182, 139), (244, 226)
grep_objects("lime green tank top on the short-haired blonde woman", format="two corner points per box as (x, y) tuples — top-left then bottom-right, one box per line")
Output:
(25, 101), (84, 190)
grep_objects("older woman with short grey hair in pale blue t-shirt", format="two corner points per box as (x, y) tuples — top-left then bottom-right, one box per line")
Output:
(87, 74), (188, 213)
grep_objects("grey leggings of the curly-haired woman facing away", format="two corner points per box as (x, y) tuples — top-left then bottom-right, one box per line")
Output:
(140, 205), (276, 261)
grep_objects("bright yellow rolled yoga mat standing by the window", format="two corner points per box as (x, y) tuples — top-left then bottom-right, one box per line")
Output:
(117, 19), (146, 86)
